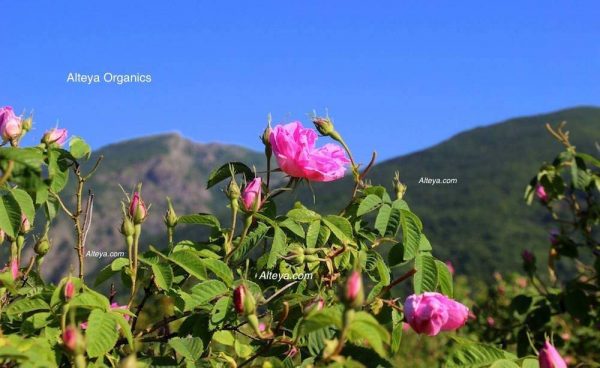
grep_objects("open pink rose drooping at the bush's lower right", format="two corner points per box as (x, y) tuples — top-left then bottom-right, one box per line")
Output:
(404, 292), (469, 336)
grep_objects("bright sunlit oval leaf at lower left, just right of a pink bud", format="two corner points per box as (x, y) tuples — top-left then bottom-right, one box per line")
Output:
(85, 309), (119, 358)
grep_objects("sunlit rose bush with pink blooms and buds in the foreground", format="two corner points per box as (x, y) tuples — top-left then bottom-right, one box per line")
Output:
(0, 108), (596, 367)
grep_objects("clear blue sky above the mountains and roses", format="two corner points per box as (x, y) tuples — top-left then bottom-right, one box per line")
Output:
(0, 0), (600, 162)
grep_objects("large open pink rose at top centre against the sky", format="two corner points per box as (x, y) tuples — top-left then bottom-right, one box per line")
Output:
(269, 121), (350, 181)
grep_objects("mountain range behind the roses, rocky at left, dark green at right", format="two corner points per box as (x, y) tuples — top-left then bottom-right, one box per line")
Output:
(39, 107), (600, 277)
